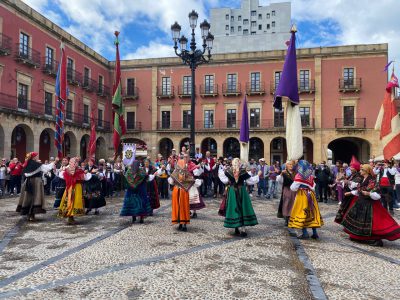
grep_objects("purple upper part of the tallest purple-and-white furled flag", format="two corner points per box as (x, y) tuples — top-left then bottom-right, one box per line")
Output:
(274, 30), (300, 110)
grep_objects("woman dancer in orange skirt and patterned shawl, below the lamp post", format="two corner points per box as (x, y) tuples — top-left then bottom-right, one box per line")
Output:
(168, 154), (201, 231)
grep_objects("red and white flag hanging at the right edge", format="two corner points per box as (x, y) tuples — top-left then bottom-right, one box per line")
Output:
(375, 73), (400, 159)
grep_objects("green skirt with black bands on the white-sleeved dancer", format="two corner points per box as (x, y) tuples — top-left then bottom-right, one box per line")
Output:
(224, 186), (258, 228)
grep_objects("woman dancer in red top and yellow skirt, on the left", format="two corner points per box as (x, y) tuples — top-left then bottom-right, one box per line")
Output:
(58, 157), (92, 225)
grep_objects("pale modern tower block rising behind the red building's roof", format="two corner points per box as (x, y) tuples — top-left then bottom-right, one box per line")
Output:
(211, 0), (291, 53)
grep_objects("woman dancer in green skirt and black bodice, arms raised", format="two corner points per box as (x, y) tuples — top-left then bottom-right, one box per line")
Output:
(218, 158), (261, 237)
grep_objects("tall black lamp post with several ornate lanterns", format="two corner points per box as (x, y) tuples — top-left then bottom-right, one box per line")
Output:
(171, 10), (214, 158)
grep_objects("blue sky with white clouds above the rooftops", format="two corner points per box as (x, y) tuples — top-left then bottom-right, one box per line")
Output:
(23, 0), (400, 70)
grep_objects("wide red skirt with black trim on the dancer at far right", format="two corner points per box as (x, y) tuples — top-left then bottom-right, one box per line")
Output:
(342, 197), (400, 241)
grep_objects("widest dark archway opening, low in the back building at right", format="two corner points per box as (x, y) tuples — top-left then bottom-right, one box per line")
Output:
(328, 137), (371, 163)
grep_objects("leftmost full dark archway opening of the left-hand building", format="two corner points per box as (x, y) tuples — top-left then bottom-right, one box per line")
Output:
(11, 124), (34, 161)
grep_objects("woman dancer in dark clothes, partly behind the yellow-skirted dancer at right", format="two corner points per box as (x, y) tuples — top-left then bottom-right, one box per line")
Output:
(276, 160), (296, 226)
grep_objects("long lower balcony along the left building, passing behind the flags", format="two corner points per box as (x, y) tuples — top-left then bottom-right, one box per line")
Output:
(0, 93), (111, 132)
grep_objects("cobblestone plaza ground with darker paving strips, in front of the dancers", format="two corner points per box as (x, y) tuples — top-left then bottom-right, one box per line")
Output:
(0, 198), (400, 299)
